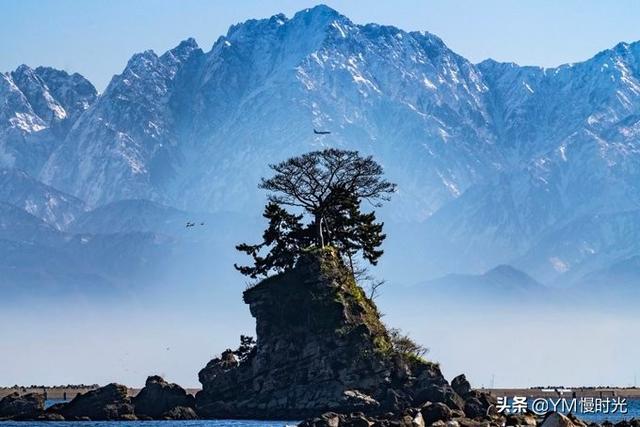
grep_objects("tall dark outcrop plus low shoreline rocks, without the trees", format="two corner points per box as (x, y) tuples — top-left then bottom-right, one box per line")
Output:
(0, 249), (640, 427)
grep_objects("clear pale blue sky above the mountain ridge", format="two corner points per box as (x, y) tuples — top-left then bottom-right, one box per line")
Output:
(0, 0), (640, 90)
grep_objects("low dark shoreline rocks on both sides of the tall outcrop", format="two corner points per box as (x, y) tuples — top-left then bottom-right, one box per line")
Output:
(0, 375), (640, 427)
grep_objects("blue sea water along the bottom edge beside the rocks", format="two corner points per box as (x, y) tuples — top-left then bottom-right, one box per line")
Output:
(0, 399), (640, 427)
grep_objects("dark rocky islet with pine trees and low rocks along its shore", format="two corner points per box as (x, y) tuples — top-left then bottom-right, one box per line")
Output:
(0, 149), (638, 427)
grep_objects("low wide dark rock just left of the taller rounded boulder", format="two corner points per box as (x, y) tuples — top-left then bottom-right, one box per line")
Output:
(50, 383), (136, 421)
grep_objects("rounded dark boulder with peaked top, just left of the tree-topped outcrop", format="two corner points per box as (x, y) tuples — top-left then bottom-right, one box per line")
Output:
(133, 375), (194, 419)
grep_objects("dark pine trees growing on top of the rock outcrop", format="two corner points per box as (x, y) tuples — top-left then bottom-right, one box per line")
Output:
(236, 149), (396, 278)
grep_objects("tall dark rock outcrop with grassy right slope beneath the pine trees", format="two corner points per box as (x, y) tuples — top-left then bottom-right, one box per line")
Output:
(196, 251), (459, 419)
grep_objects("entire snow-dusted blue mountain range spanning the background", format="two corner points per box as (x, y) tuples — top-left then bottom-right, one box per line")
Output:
(0, 6), (640, 285)
